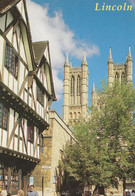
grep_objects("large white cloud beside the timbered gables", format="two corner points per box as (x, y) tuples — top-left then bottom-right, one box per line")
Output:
(27, 0), (99, 99)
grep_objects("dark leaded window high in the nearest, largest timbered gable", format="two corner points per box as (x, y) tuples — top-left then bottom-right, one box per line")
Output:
(5, 44), (18, 78)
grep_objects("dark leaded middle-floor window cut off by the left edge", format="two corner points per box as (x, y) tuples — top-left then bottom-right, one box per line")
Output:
(0, 103), (9, 130)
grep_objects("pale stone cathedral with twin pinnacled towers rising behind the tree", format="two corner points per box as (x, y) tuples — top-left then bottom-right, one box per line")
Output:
(63, 46), (133, 125)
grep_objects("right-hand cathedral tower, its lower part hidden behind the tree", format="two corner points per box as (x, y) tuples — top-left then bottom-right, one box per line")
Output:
(108, 46), (133, 86)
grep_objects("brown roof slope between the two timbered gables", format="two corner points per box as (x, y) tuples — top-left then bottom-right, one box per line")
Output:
(33, 41), (48, 64)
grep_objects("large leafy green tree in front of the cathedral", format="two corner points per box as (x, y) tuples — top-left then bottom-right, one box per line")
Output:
(61, 82), (135, 194)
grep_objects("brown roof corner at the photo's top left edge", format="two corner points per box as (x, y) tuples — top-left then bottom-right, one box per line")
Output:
(0, 0), (20, 14)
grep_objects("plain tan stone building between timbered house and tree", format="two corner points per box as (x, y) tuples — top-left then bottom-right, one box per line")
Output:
(32, 110), (75, 196)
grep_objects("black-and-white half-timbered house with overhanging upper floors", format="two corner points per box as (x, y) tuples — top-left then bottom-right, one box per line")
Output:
(0, 0), (55, 194)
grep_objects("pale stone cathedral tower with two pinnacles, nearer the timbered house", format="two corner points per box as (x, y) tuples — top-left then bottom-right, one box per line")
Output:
(63, 52), (88, 125)
